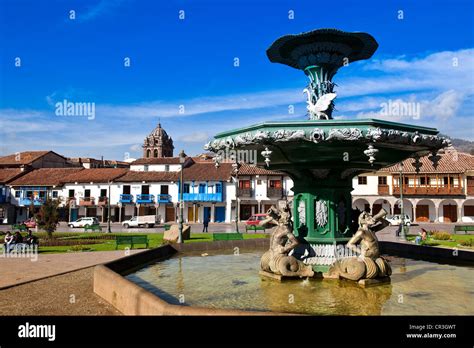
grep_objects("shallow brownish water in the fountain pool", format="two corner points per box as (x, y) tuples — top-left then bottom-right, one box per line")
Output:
(126, 250), (474, 315)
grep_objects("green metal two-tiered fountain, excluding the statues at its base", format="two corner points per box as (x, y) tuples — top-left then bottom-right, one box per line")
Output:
(205, 29), (449, 273)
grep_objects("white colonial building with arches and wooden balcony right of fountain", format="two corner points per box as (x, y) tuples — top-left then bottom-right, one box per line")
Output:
(352, 148), (474, 223)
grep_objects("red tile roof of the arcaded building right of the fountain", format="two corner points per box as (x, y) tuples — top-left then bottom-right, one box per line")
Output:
(380, 150), (474, 174)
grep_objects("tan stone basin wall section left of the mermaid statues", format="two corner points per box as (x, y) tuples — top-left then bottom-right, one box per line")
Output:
(94, 239), (286, 316)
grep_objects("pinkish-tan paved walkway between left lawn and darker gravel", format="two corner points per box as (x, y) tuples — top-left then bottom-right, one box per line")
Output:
(0, 250), (144, 290)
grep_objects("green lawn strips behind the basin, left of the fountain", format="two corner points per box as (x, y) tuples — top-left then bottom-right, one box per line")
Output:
(35, 232), (269, 254)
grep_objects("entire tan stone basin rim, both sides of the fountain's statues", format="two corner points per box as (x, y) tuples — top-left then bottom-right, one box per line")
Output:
(94, 239), (474, 316)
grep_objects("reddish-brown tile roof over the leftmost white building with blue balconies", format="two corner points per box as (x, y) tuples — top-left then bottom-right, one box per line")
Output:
(9, 168), (86, 186)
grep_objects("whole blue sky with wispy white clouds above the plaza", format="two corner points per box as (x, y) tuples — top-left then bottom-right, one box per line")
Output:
(0, 0), (474, 159)
